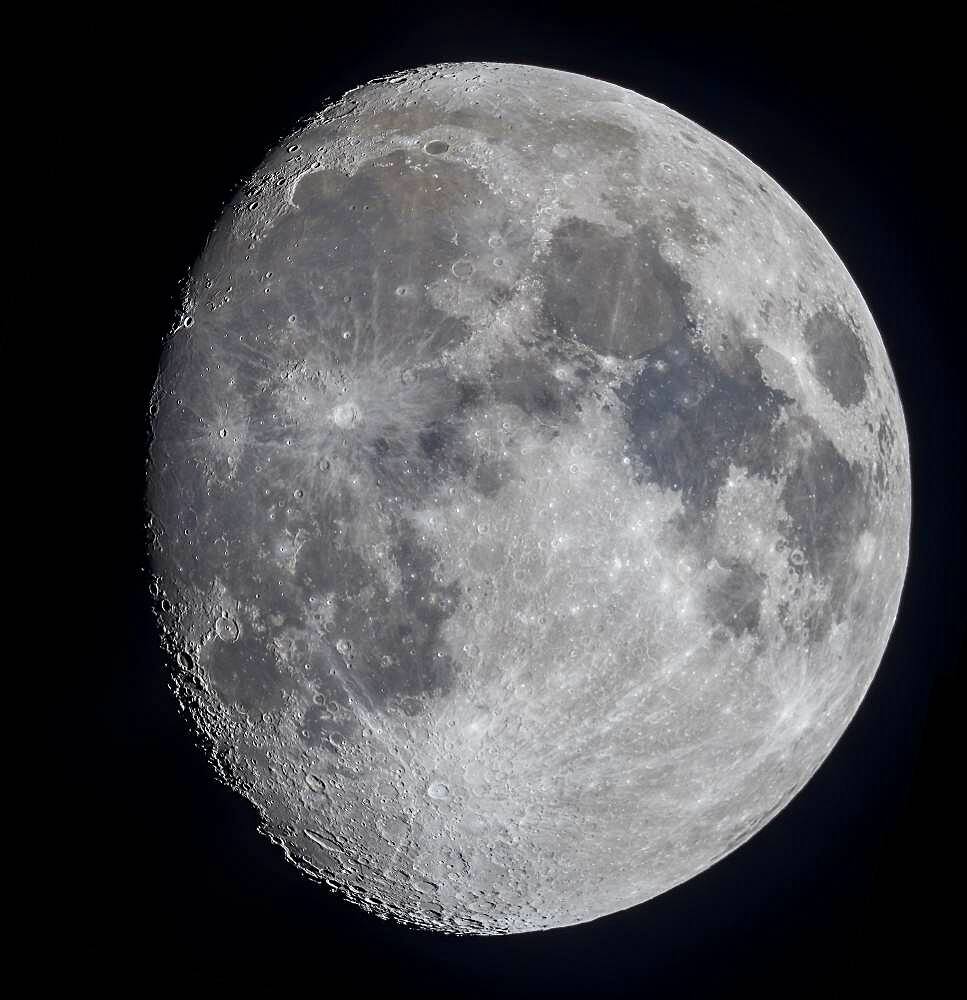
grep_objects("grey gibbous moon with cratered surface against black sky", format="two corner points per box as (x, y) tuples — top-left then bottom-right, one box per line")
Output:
(147, 63), (910, 934)
